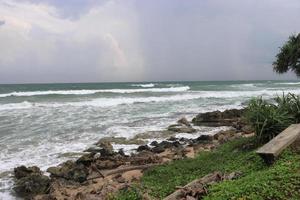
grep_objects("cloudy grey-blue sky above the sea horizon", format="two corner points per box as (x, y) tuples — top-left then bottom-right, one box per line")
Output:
(0, 0), (300, 83)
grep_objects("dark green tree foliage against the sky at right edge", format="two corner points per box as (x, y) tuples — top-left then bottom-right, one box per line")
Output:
(273, 33), (300, 77)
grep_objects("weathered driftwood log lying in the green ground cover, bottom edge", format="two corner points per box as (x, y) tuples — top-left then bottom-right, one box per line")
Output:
(164, 172), (222, 200)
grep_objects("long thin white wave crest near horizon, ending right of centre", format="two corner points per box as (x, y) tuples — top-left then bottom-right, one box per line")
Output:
(0, 86), (190, 97)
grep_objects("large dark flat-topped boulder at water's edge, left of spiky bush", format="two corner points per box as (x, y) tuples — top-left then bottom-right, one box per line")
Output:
(192, 109), (245, 126)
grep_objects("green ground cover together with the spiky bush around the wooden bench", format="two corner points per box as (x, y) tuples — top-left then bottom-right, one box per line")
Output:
(114, 94), (300, 200)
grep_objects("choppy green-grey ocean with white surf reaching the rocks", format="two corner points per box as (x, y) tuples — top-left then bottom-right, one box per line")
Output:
(0, 81), (300, 200)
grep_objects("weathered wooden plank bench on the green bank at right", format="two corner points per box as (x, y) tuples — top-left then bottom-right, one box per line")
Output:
(256, 124), (300, 164)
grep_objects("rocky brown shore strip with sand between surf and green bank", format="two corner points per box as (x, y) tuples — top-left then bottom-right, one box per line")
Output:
(14, 109), (252, 200)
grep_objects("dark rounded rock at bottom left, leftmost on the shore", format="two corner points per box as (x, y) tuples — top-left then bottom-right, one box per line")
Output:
(13, 173), (50, 199)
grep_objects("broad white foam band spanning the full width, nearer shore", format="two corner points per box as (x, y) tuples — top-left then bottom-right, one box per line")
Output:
(0, 89), (300, 110)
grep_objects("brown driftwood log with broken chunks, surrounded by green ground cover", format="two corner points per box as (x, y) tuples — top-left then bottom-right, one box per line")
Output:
(164, 172), (222, 200)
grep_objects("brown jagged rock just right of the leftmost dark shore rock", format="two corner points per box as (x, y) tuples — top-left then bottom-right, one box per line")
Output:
(47, 161), (88, 183)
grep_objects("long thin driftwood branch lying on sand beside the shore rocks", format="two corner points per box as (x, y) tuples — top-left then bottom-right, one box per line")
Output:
(88, 164), (157, 180)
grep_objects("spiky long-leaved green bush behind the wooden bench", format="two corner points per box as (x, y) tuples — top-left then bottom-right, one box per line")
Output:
(245, 94), (299, 143)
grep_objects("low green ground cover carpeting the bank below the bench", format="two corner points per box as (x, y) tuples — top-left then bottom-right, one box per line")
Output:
(115, 139), (300, 200)
